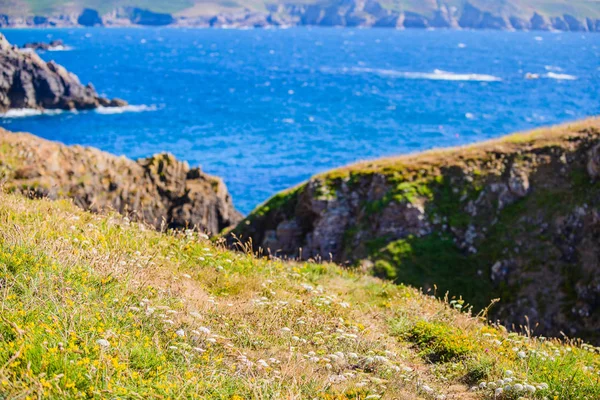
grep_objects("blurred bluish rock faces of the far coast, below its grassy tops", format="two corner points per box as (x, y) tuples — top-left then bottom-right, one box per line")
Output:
(0, 0), (600, 32)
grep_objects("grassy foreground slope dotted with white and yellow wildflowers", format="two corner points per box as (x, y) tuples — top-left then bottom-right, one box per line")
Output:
(0, 186), (600, 400)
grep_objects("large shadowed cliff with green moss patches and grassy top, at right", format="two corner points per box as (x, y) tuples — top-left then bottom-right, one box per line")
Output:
(231, 119), (600, 344)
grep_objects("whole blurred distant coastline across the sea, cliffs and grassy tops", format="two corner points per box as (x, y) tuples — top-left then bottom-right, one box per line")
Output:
(0, 0), (600, 32)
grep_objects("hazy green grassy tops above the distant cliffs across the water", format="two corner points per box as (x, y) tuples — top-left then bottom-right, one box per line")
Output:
(8, 0), (600, 18)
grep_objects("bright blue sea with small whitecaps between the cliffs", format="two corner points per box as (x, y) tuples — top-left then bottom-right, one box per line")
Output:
(0, 28), (600, 212)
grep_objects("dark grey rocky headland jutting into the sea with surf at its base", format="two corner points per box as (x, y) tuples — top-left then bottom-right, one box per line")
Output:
(0, 34), (127, 112)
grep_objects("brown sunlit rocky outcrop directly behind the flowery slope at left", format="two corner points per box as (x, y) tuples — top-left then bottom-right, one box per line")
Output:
(0, 129), (241, 234)
